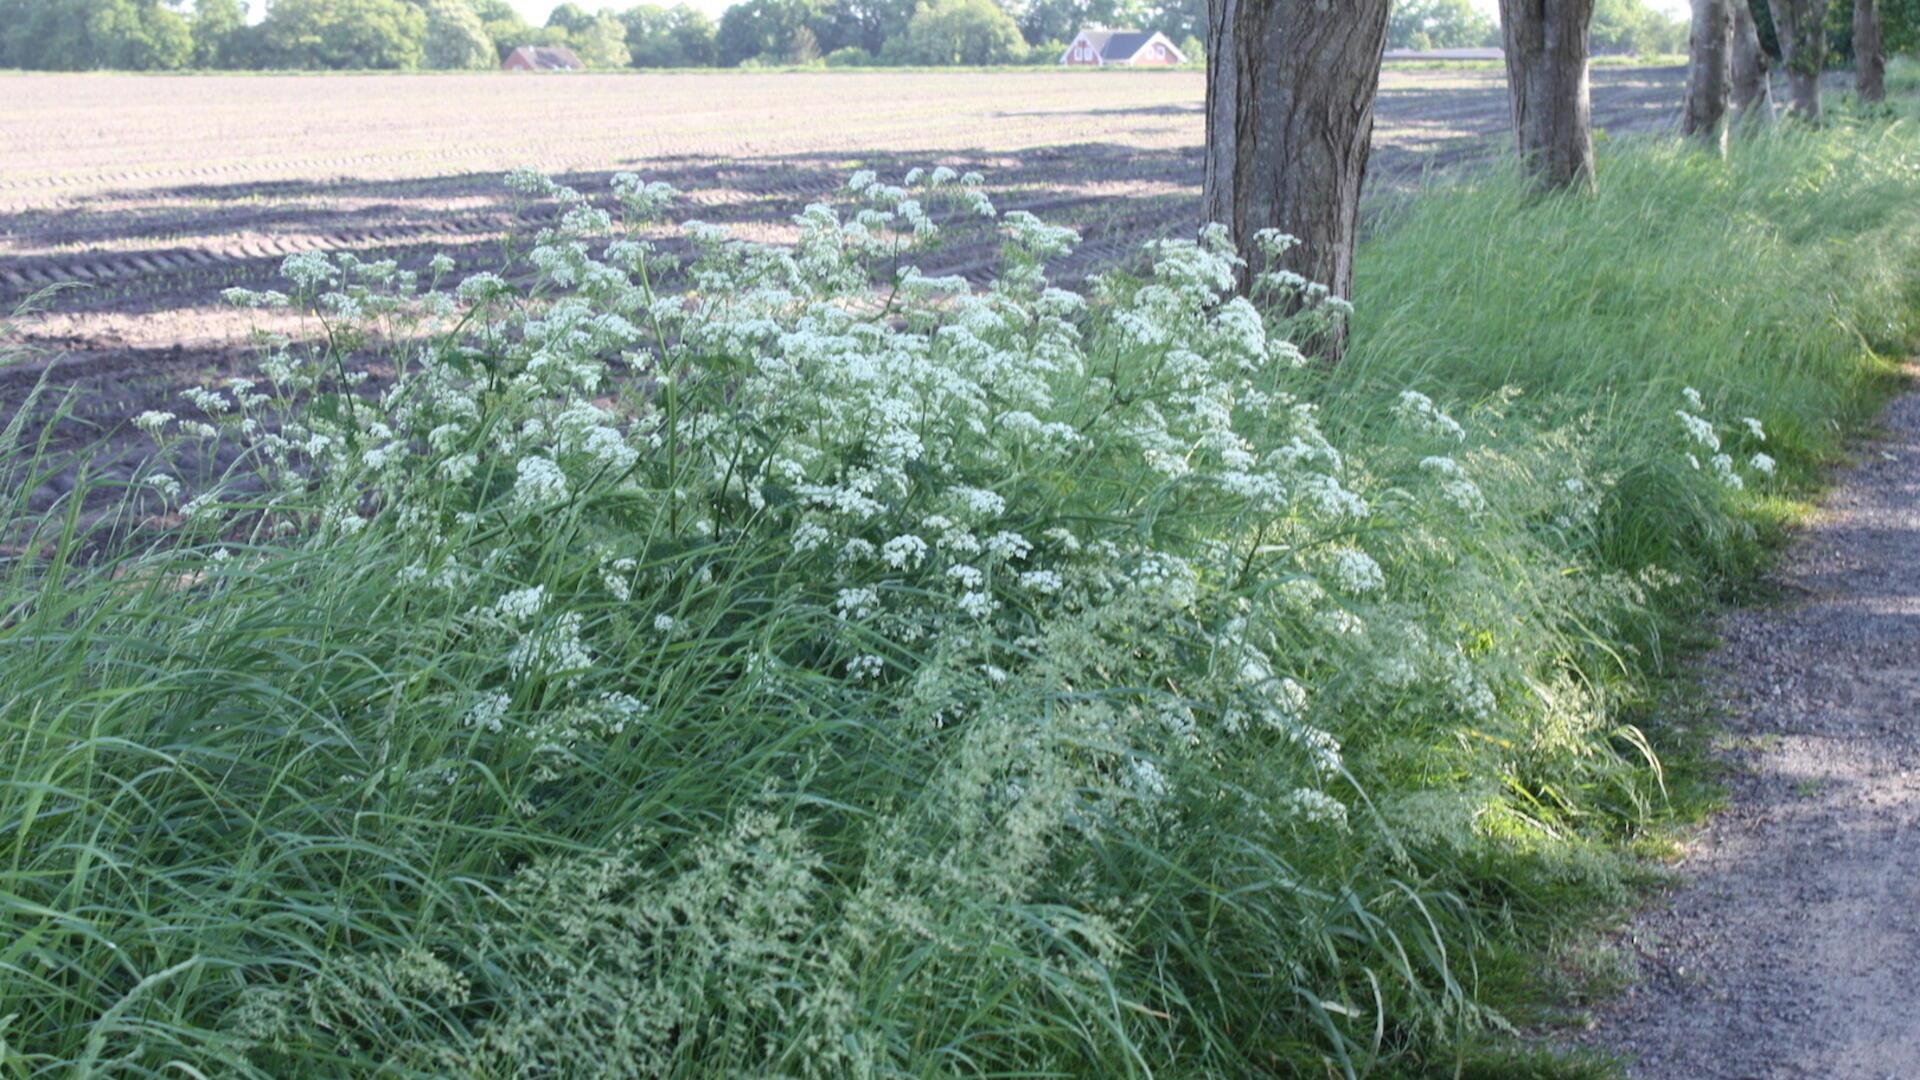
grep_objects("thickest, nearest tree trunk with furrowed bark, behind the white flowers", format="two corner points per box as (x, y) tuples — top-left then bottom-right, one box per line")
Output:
(1206, 0), (1390, 343)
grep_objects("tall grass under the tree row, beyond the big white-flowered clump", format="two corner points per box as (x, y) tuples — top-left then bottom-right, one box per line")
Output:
(1334, 119), (1920, 588)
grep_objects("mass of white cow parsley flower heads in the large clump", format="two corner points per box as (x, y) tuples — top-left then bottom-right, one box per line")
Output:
(187, 169), (1484, 799)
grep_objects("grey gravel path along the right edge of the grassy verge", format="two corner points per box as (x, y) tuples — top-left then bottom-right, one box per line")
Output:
(1594, 367), (1920, 1080)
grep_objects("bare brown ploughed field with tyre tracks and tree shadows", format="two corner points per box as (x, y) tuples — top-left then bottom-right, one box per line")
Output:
(0, 69), (1684, 505)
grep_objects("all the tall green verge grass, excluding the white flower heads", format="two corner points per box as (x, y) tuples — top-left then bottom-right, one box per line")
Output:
(0, 107), (1920, 1076)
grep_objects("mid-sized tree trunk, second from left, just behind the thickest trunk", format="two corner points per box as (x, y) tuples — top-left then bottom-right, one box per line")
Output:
(1500, 0), (1594, 188)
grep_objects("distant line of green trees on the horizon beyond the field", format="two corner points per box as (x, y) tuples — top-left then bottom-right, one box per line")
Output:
(0, 0), (1920, 71)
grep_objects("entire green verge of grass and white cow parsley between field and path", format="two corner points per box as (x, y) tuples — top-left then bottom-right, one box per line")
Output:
(0, 98), (1920, 1078)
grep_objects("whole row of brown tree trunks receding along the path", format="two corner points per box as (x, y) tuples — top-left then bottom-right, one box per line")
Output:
(1204, 0), (1920, 357)
